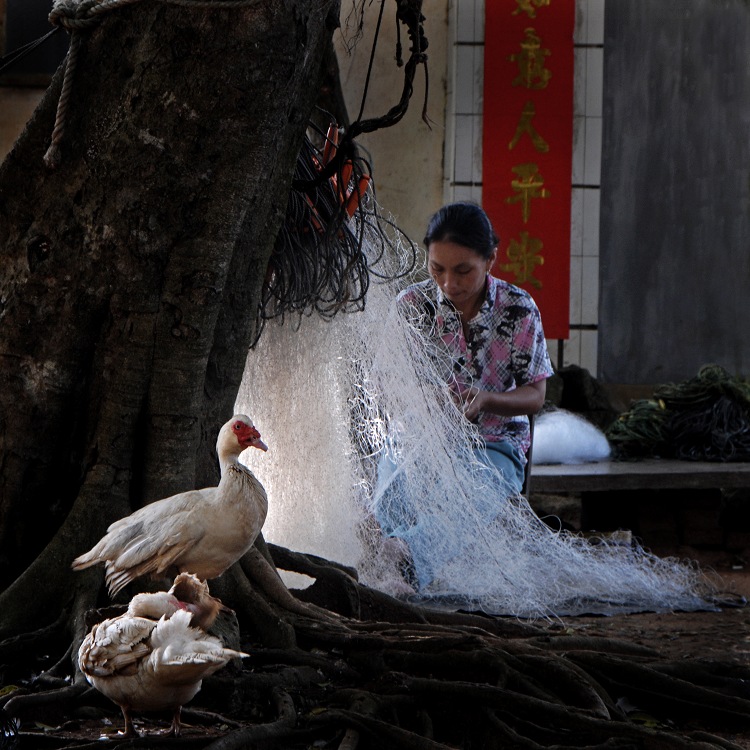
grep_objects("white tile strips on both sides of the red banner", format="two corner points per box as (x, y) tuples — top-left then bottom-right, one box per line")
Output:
(444, 0), (605, 375)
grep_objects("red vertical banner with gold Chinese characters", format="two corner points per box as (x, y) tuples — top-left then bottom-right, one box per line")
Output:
(482, 0), (575, 339)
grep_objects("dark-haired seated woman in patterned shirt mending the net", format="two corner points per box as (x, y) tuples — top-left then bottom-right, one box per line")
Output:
(374, 203), (553, 588)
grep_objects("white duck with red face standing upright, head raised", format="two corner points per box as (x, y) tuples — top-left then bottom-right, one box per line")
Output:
(72, 414), (268, 596)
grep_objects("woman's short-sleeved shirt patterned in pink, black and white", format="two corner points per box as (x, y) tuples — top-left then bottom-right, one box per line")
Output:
(398, 274), (554, 456)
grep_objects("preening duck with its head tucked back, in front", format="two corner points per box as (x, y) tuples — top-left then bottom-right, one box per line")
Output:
(78, 576), (247, 737)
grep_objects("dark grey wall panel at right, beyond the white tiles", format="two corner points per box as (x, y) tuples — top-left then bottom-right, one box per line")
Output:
(599, 0), (750, 383)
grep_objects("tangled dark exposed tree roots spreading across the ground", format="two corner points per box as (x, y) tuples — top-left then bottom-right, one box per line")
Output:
(0, 544), (750, 750)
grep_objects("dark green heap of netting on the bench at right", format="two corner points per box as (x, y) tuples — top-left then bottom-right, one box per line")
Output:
(606, 365), (750, 461)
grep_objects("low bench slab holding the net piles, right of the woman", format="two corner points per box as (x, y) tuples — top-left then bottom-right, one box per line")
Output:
(530, 458), (750, 495)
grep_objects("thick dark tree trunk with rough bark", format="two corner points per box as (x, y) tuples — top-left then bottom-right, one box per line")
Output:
(0, 0), (338, 637)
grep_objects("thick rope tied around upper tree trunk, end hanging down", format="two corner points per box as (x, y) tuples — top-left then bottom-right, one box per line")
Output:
(44, 0), (268, 170)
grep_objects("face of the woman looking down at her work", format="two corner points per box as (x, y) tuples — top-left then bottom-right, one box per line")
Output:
(427, 242), (497, 313)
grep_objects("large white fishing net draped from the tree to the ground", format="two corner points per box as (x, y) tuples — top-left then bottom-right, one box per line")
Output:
(237, 197), (714, 617)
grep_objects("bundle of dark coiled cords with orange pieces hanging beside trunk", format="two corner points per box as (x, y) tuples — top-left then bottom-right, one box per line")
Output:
(252, 123), (418, 347)
